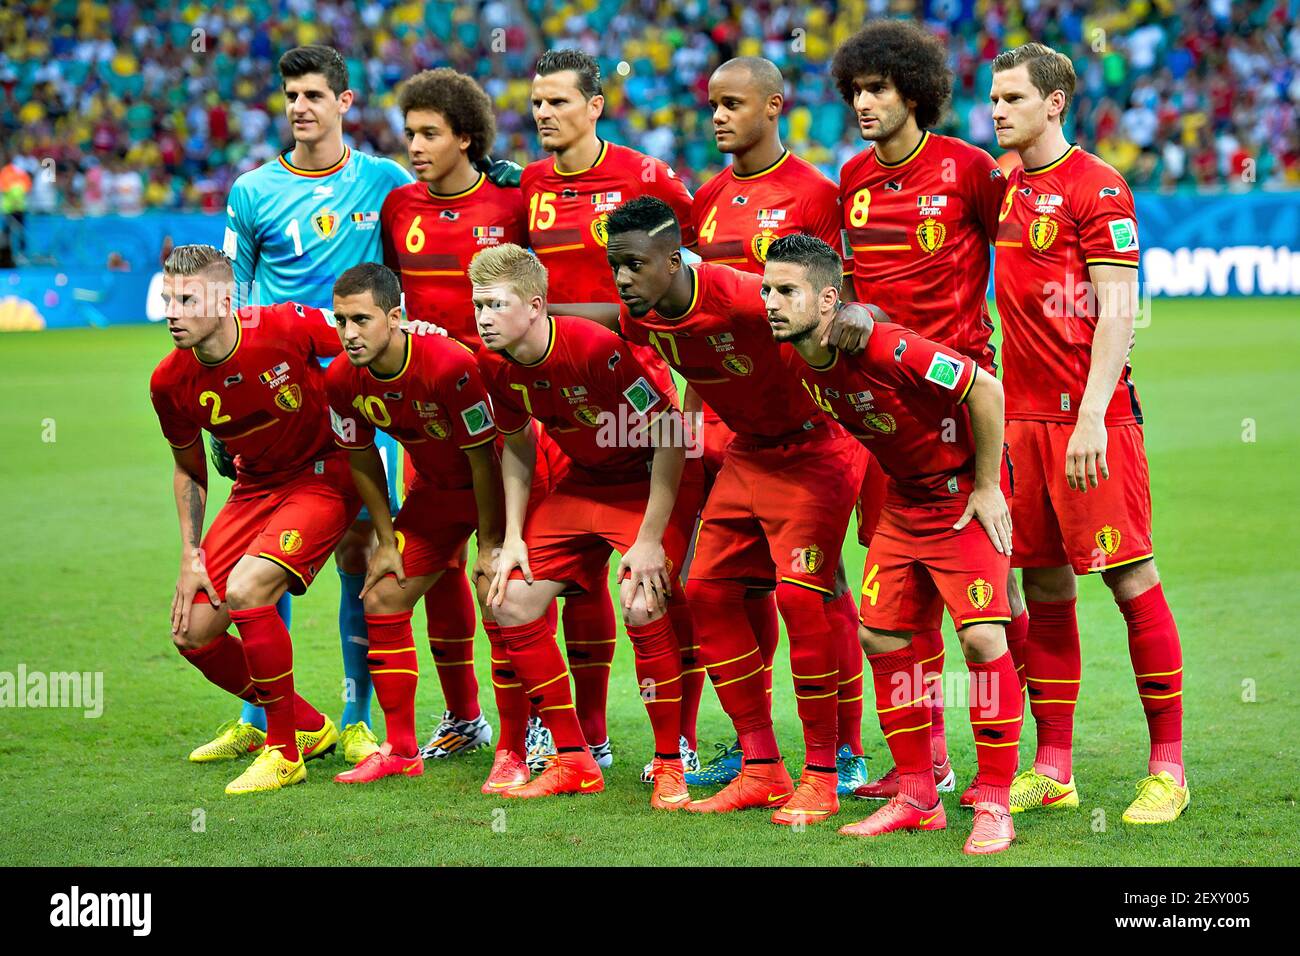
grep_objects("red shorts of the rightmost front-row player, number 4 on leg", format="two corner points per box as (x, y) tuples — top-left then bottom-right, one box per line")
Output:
(858, 501), (1011, 633)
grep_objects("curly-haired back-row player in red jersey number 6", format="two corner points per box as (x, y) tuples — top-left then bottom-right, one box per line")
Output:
(380, 69), (528, 758)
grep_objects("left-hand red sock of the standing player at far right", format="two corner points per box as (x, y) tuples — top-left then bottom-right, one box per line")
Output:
(1024, 600), (1083, 783)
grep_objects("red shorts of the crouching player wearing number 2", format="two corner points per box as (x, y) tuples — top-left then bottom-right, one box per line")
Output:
(195, 451), (361, 601)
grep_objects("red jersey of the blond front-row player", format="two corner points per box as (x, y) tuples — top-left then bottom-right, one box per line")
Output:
(478, 315), (670, 483)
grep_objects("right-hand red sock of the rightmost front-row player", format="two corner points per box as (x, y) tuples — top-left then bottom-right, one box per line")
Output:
(966, 653), (1024, 809)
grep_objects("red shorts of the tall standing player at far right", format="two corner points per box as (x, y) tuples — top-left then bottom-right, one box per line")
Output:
(1006, 421), (1152, 575)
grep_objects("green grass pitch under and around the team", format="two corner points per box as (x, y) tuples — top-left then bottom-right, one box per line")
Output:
(0, 299), (1300, 866)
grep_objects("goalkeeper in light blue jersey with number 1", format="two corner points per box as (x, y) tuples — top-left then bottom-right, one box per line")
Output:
(217, 46), (411, 762)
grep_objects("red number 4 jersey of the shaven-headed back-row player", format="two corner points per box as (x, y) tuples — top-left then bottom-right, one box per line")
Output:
(692, 151), (849, 274)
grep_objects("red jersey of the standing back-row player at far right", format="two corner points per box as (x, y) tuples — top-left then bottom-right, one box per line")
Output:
(996, 146), (1141, 425)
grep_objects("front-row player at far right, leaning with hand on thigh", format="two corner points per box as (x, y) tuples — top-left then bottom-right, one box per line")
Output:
(763, 234), (1024, 853)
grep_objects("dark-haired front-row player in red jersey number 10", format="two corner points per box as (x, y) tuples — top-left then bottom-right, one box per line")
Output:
(325, 263), (509, 783)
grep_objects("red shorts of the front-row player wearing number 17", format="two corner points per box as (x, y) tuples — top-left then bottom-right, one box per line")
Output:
(690, 431), (867, 594)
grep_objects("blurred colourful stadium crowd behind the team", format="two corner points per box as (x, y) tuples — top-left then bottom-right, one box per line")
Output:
(0, 0), (1300, 215)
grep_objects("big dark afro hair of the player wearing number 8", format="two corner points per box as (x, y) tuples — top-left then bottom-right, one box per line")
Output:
(831, 20), (953, 130)
